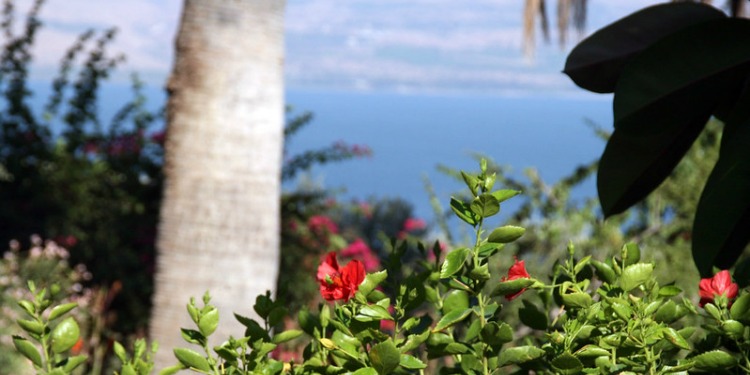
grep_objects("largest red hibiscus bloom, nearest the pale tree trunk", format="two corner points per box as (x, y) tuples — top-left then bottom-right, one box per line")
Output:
(318, 252), (365, 302)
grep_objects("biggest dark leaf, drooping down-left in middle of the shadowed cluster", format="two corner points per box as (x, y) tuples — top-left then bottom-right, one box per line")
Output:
(597, 19), (750, 216)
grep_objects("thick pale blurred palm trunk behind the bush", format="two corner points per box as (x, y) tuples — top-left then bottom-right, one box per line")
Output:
(150, 0), (285, 369)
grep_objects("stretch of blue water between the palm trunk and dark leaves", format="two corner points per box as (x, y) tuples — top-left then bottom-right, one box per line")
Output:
(287, 91), (612, 219)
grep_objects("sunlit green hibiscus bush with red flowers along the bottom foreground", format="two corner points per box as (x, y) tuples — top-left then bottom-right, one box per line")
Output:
(13, 163), (750, 375)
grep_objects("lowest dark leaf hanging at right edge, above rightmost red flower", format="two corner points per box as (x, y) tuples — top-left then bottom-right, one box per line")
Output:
(693, 91), (750, 277)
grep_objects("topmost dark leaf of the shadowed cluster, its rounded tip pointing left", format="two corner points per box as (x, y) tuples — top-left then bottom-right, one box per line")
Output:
(564, 3), (726, 93)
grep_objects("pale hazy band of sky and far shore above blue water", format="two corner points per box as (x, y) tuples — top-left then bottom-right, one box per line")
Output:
(18, 0), (660, 93)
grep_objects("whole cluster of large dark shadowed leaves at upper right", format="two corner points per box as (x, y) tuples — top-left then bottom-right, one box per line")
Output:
(565, 3), (750, 276)
